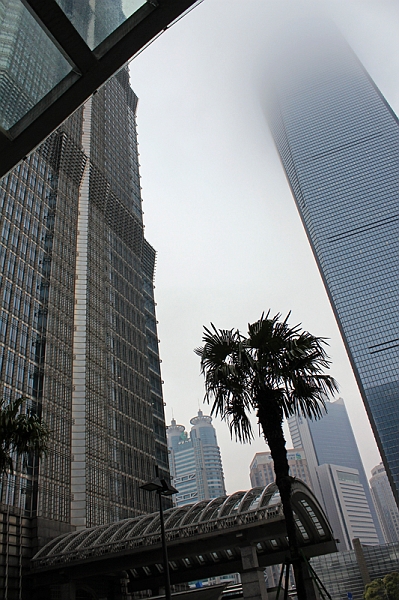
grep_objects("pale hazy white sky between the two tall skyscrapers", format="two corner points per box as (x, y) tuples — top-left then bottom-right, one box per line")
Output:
(131, 0), (399, 493)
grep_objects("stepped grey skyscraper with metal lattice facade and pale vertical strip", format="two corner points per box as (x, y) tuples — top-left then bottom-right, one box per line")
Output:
(0, 69), (168, 598)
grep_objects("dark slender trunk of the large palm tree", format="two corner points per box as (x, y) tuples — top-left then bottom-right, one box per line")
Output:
(257, 398), (307, 600)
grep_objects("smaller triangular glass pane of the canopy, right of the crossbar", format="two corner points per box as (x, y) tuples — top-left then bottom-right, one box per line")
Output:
(57, 0), (147, 50)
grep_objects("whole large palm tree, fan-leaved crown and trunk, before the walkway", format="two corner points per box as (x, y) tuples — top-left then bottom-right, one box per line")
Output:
(195, 311), (337, 600)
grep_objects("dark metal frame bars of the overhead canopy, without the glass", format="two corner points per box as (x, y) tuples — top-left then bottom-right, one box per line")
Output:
(0, 0), (202, 177)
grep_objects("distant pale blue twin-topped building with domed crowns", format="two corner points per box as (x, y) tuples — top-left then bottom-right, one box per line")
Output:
(167, 410), (226, 506)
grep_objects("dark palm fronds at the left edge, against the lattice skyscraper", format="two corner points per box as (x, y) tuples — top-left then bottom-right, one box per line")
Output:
(0, 398), (50, 474)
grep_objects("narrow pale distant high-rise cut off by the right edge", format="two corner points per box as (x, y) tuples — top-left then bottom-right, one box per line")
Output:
(370, 463), (399, 543)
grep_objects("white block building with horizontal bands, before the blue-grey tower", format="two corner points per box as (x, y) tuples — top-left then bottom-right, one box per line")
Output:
(316, 464), (379, 551)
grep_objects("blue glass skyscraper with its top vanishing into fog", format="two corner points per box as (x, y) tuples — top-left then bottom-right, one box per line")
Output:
(268, 7), (399, 501)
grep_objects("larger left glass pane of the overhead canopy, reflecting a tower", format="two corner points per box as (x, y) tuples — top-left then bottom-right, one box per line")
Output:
(0, 0), (72, 130)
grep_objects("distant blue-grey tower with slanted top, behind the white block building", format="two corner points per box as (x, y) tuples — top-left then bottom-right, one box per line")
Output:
(288, 398), (384, 544)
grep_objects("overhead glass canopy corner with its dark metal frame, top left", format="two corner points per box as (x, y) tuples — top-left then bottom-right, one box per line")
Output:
(0, 0), (202, 177)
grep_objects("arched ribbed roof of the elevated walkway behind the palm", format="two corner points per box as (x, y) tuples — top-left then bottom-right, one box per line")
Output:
(32, 480), (336, 578)
